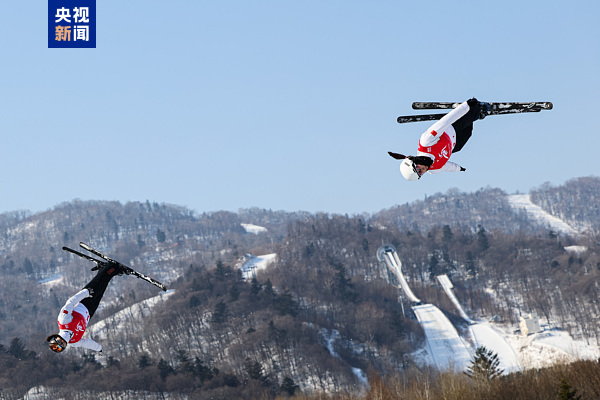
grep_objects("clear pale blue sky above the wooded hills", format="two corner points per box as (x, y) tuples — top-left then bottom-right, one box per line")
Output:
(0, 0), (600, 214)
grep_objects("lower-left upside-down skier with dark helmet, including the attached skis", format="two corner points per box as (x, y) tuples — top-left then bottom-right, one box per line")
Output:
(46, 243), (167, 354)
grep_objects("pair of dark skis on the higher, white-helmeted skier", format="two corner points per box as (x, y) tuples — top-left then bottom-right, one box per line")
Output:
(398, 101), (552, 124)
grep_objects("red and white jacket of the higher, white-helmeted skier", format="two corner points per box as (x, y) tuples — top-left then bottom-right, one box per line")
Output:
(417, 101), (469, 174)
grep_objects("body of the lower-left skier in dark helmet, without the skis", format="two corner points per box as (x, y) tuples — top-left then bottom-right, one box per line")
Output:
(46, 264), (127, 353)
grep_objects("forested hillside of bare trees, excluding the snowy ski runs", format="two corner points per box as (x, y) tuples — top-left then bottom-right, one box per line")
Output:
(0, 178), (600, 399)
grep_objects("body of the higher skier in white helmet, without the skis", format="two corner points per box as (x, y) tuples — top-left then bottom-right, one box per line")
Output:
(388, 98), (490, 181)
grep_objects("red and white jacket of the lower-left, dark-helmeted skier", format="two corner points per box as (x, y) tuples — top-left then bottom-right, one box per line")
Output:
(58, 289), (102, 351)
